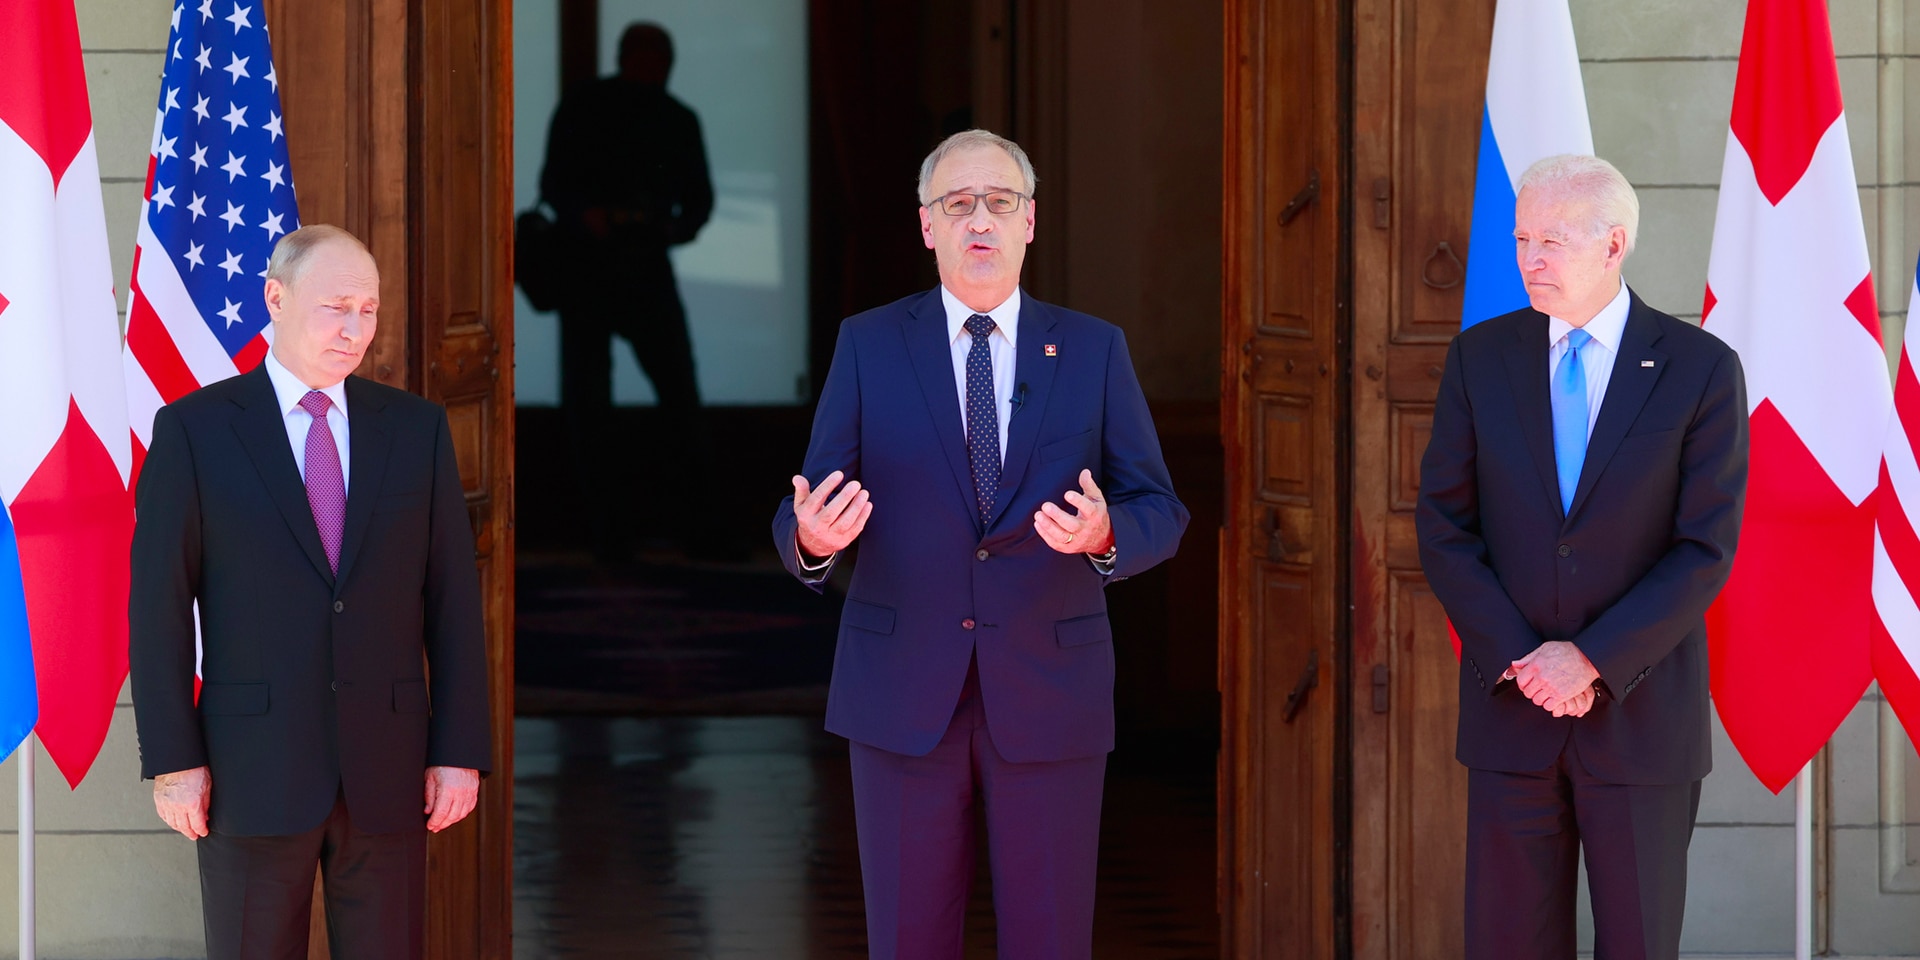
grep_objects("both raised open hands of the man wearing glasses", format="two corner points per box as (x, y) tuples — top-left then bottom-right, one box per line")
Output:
(793, 470), (1114, 557)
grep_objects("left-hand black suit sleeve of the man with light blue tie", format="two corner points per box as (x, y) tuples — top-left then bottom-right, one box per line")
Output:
(1413, 338), (1540, 697)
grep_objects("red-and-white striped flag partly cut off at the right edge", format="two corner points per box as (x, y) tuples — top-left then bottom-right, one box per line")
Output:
(1872, 259), (1920, 741)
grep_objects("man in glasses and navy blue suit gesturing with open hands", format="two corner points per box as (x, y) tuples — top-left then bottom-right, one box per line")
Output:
(774, 131), (1187, 960)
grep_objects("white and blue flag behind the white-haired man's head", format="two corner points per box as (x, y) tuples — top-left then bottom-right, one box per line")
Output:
(1459, 0), (1594, 330)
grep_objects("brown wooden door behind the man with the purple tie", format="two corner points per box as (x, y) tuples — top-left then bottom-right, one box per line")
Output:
(267, 0), (513, 960)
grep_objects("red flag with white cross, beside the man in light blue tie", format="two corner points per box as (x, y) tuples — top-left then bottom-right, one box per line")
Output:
(1703, 0), (1893, 793)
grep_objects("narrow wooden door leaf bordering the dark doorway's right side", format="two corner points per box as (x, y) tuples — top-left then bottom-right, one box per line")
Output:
(1219, 0), (1346, 960)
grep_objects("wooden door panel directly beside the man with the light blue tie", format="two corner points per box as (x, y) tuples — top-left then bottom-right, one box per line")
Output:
(1352, 0), (1494, 960)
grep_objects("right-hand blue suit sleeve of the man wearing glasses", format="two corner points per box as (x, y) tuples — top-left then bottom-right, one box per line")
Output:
(1096, 332), (1188, 582)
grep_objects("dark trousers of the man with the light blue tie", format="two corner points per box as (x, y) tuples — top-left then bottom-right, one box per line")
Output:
(1467, 737), (1699, 960)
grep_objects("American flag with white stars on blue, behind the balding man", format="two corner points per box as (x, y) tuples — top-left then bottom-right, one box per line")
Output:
(125, 0), (300, 478)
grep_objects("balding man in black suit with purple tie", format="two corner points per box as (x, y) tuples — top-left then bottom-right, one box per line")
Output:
(129, 227), (492, 960)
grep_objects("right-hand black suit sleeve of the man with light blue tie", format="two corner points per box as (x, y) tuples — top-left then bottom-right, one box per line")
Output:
(1574, 349), (1747, 699)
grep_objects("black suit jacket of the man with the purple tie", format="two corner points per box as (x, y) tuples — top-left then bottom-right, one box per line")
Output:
(129, 365), (492, 835)
